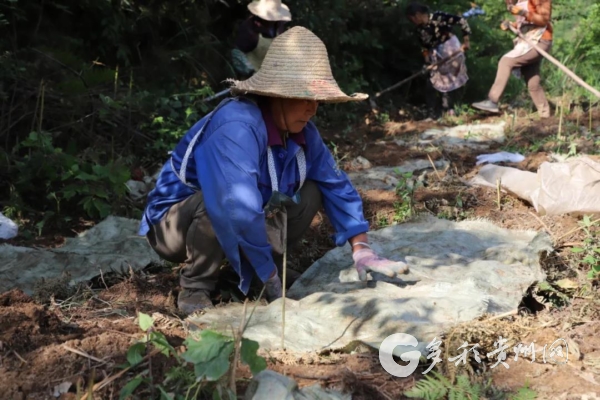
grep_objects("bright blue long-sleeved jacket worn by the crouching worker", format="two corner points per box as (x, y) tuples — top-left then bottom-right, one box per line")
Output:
(139, 98), (369, 294)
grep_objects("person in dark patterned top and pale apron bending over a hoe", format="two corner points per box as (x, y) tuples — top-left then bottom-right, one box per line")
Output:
(406, 3), (471, 119)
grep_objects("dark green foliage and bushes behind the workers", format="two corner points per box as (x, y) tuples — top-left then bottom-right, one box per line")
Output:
(0, 0), (600, 233)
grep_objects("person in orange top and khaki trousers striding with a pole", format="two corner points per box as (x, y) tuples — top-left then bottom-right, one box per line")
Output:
(472, 0), (553, 118)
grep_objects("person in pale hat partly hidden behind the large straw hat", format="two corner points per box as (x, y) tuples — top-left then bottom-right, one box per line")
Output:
(232, 0), (292, 77)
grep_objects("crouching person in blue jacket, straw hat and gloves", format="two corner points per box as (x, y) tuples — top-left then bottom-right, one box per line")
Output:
(139, 27), (408, 314)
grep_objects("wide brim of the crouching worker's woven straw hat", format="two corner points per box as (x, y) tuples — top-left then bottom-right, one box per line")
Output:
(229, 75), (369, 103)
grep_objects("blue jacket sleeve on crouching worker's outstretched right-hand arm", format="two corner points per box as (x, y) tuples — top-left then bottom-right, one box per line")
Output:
(305, 123), (369, 246)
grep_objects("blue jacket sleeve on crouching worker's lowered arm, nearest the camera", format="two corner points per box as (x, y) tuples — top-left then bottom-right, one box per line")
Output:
(194, 122), (275, 282)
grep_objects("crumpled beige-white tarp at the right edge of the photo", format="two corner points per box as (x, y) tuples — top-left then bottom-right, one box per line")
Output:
(470, 157), (600, 215)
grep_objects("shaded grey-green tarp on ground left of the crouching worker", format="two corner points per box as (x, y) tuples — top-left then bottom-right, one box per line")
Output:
(0, 217), (160, 295)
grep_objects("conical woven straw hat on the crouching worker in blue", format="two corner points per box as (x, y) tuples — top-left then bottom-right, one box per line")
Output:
(231, 26), (369, 103)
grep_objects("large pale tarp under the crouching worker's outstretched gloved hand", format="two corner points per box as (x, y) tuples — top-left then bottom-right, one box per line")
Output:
(189, 216), (551, 355)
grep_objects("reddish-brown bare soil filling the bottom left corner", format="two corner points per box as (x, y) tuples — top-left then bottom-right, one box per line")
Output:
(0, 273), (197, 399)
